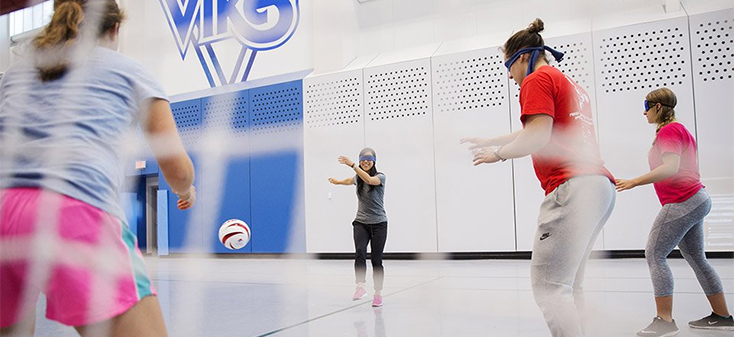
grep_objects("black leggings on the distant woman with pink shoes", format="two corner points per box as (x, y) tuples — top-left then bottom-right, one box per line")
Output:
(352, 221), (387, 290)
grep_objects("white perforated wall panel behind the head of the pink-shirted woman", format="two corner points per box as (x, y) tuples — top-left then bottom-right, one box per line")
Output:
(593, 13), (695, 250)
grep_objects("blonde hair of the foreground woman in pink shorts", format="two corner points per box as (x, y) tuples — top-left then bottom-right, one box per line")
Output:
(33, 0), (125, 82)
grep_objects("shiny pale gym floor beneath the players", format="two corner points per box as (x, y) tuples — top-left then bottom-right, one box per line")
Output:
(31, 257), (734, 337)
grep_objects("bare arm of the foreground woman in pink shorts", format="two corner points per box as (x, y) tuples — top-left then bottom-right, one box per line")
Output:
(143, 99), (196, 209)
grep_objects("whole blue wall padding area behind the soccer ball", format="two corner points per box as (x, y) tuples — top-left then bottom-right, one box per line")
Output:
(128, 80), (305, 255)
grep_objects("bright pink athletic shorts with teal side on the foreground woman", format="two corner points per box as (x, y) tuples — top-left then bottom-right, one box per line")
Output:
(0, 188), (155, 328)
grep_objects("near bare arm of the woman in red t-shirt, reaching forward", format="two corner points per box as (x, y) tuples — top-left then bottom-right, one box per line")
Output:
(474, 114), (553, 165)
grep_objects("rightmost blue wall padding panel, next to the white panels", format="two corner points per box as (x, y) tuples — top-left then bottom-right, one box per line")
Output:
(250, 81), (305, 253)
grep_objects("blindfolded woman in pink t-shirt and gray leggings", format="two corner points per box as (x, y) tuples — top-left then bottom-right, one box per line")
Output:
(616, 88), (734, 336)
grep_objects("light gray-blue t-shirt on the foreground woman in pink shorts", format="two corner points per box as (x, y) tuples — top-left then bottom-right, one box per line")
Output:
(0, 47), (167, 219)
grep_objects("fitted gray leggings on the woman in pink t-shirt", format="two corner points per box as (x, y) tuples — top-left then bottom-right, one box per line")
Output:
(645, 188), (724, 297)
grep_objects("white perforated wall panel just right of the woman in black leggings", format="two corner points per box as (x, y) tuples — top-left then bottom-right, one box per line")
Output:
(364, 58), (437, 252)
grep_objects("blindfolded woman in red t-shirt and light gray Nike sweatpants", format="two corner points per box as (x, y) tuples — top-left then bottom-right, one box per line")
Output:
(462, 19), (615, 337)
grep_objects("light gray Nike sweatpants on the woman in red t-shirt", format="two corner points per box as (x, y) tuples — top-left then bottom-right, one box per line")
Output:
(530, 175), (616, 337)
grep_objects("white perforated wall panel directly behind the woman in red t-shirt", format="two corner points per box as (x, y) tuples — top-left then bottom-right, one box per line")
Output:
(510, 32), (604, 251)
